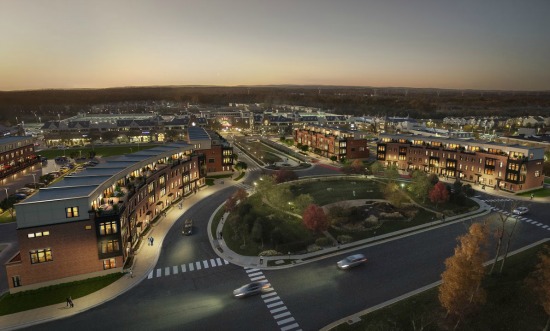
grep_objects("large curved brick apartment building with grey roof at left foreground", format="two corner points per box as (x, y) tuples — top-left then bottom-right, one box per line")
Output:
(5, 129), (231, 293)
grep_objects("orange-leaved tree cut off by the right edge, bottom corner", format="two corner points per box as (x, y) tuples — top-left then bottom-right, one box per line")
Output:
(525, 245), (550, 331)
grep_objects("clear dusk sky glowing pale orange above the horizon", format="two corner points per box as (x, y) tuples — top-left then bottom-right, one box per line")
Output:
(0, 0), (550, 91)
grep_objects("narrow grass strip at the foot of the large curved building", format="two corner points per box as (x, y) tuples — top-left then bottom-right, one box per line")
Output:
(0, 273), (124, 316)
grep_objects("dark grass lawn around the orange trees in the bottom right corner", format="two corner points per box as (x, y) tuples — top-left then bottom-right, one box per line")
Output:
(332, 246), (548, 331)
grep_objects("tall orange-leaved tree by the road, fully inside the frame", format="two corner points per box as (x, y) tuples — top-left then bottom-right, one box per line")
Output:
(438, 223), (488, 329)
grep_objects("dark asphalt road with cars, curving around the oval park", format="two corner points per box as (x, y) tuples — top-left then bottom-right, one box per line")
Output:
(28, 188), (550, 330)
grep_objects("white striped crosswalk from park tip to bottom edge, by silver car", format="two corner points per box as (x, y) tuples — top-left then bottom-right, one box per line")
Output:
(245, 268), (301, 331)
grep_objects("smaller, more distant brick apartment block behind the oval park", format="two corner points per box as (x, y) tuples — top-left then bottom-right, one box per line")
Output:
(294, 125), (369, 161)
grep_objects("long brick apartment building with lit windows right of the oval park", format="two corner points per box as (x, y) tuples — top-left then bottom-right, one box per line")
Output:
(377, 135), (544, 192)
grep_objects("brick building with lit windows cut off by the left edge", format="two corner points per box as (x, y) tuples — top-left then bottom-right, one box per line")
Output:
(0, 136), (40, 179)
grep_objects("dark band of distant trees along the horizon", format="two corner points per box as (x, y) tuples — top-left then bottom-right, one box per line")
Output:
(0, 86), (550, 125)
